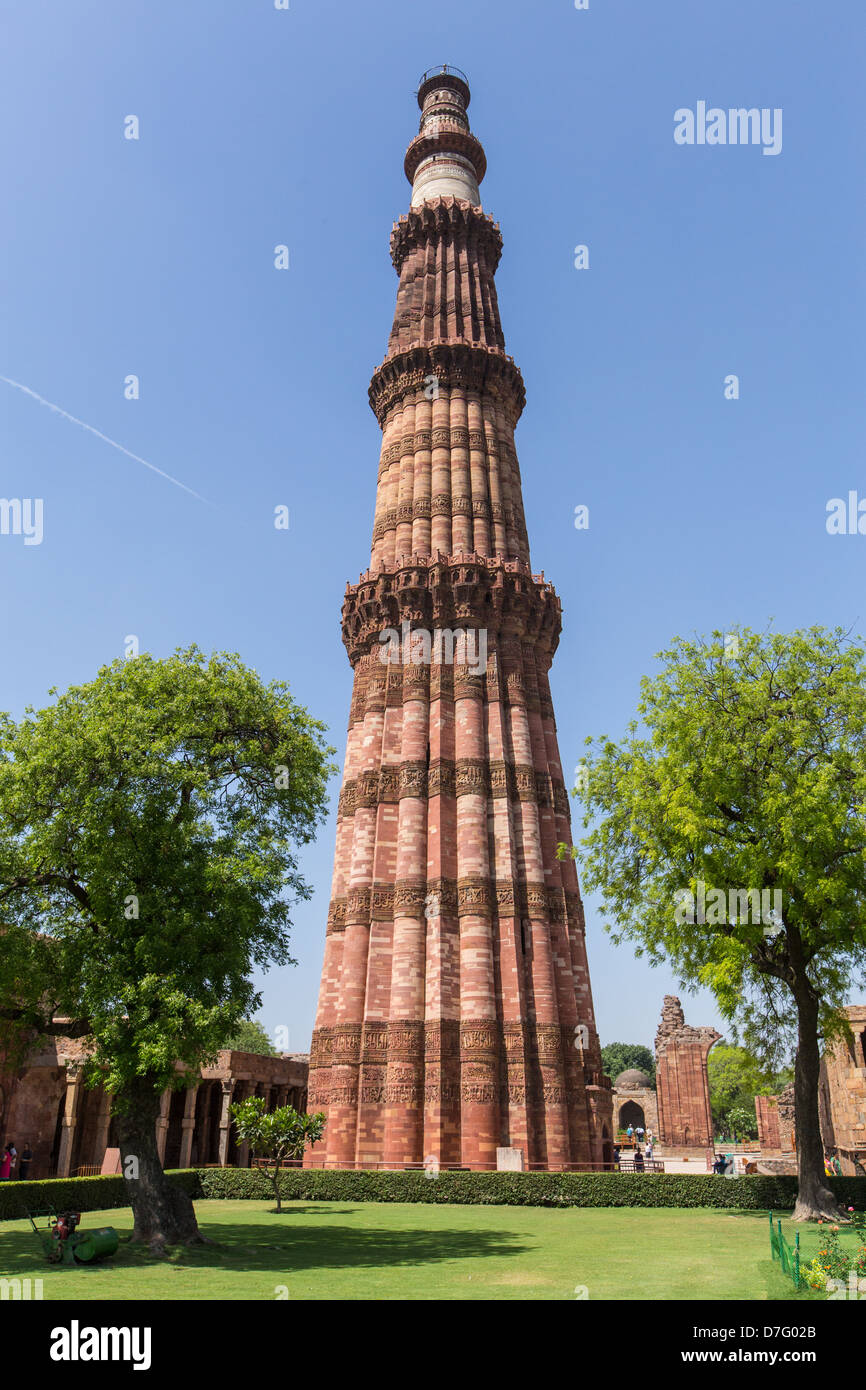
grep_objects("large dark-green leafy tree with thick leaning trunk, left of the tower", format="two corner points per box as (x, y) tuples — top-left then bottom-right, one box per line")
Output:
(0, 646), (332, 1248)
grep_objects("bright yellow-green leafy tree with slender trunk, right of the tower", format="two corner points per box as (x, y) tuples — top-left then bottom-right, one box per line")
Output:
(562, 628), (866, 1220)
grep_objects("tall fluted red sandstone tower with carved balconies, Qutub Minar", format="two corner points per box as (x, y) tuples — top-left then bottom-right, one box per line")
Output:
(307, 68), (610, 1168)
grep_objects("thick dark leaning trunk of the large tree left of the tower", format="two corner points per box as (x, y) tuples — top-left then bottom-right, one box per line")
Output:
(115, 1076), (203, 1252)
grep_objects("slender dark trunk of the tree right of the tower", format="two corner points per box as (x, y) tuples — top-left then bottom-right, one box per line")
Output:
(794, 979), (844, 1220)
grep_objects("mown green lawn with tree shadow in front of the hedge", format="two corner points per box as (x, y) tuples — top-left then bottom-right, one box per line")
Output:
(0, 1201), (839, 1301)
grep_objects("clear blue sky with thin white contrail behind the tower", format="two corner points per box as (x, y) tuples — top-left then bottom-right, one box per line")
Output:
(0, 0), (866, 1051)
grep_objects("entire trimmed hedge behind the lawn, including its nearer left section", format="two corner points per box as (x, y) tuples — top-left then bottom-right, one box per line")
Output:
(0, 1168), (866, 1220)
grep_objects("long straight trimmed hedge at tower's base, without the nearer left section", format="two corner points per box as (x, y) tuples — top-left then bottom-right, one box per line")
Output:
(199, 1168), (866, 1212)
